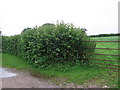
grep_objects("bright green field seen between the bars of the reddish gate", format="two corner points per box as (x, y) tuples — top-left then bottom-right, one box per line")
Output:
(92, 36), (120, 68)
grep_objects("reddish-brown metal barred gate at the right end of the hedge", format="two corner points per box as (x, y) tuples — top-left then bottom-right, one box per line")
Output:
(80, 40), (120, 72)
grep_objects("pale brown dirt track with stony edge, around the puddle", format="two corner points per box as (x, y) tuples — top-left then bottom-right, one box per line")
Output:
(0, 69), (108, 89)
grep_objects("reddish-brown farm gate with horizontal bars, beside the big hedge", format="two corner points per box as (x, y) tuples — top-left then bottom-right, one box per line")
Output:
(81, 37), (120, 72)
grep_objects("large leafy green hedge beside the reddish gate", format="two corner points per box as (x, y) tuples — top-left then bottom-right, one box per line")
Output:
(3, 22), (96, 67)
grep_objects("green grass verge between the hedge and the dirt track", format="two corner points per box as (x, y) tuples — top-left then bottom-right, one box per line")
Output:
(0, 53), (118, 88)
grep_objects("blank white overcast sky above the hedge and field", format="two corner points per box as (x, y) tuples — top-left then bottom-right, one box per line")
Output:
(0, 0), (119, 36)
